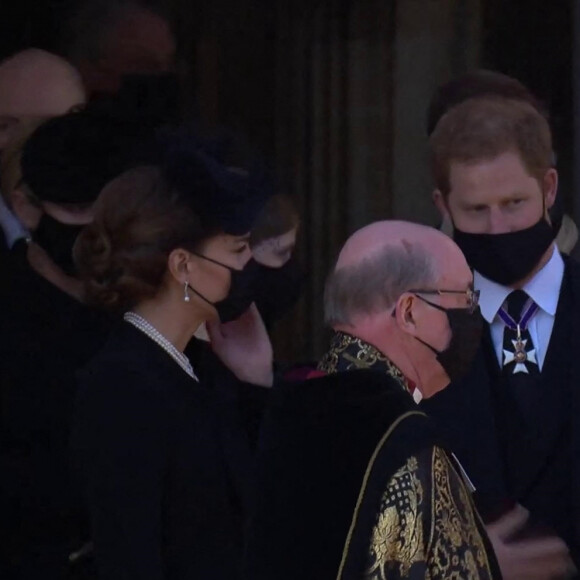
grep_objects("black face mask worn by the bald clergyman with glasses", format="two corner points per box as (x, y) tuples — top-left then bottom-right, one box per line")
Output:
(416, 294), (483, 383)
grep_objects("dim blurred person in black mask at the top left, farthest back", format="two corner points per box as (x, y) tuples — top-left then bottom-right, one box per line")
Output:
(62, 0), (182, 138)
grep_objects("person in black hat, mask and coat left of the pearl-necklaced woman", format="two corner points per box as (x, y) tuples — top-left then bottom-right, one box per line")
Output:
(0, 106), (156, 580)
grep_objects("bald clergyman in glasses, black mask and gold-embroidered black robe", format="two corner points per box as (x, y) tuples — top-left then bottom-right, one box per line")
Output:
(244, 221), (500, 580)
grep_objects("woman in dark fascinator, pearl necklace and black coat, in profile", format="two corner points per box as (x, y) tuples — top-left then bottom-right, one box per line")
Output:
(73, 139), (272, 580)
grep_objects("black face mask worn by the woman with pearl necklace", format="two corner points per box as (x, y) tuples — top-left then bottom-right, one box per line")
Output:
(188, 254), (259, 322)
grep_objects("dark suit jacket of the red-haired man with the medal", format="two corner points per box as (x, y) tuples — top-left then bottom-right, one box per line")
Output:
(421, 257), (580, 561)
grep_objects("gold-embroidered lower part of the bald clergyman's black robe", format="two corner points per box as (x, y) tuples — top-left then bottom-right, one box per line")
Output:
(365, 447), (492, 580)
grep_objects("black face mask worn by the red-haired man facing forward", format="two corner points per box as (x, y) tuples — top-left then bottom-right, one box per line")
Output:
(453, 217), (557, 286)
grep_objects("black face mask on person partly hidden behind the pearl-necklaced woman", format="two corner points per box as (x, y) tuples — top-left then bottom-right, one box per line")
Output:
(254, 258), (305, 323)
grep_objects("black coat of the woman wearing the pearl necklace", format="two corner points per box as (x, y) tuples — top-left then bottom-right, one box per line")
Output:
(73, 323), (263, 580)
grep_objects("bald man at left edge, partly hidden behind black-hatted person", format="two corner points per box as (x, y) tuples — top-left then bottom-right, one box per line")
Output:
(0, 49), (86, 248)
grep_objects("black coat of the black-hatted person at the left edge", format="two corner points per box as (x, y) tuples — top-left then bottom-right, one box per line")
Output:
(0, 244), (110, 579)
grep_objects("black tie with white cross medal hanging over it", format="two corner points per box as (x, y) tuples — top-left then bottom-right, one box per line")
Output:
(502, 290), (540, 376)
